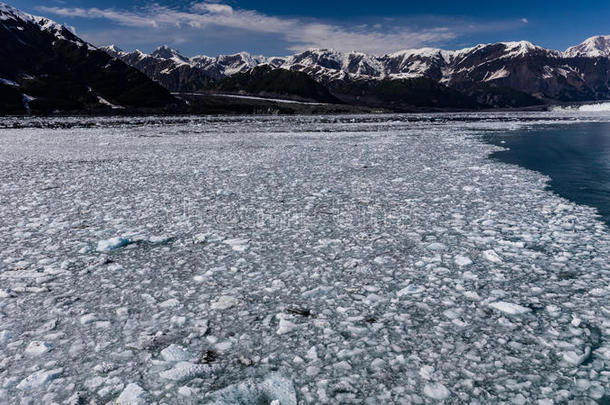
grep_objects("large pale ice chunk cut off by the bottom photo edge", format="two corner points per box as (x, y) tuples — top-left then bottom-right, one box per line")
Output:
(204, 374), (297, 405)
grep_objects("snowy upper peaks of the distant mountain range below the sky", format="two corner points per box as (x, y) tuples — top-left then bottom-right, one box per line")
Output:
(102, 36), (610, 90)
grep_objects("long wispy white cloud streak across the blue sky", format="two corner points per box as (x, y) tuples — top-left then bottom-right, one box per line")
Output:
(38, 1), (524, 54)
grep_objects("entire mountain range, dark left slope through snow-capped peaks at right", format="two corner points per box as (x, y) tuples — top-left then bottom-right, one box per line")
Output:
(0, 3), (610, 112)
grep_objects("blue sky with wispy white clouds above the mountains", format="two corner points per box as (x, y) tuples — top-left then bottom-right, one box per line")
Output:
(8, 0), (610, 56)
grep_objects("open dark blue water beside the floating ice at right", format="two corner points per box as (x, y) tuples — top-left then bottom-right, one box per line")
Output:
(487, 123), (610, 226)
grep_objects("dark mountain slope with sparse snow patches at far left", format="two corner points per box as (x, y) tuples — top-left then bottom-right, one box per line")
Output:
(0, 3), (176, 114)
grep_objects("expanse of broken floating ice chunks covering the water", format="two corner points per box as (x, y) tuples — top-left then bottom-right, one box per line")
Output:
(0, 111), (610, 405)
